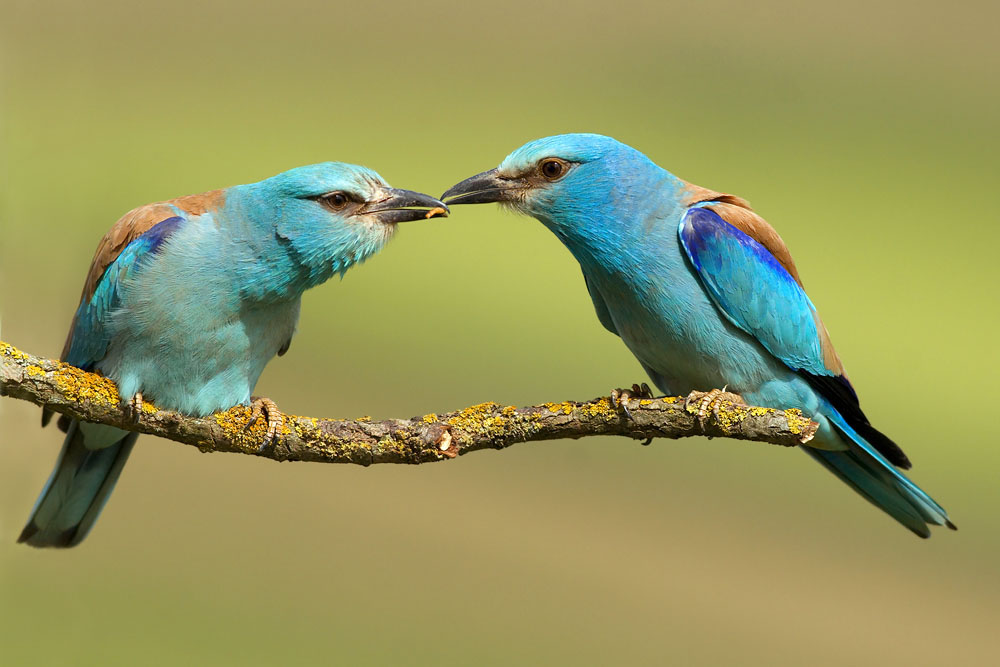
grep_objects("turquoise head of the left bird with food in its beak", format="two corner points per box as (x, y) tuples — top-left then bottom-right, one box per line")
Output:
(234, 162), (448, 287)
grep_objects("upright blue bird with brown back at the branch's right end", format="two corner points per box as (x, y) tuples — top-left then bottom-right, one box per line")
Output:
(441, 133), (955, 538)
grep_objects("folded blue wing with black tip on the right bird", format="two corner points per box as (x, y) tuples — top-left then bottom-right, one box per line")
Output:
(679, 205), (909, 468)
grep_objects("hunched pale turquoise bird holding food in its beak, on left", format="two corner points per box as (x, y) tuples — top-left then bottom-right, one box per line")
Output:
(18, 162), (447, 547)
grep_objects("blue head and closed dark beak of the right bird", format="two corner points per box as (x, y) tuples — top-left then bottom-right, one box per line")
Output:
(441, 134), (681, 258)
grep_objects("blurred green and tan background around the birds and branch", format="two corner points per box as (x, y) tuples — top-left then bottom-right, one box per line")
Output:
(0, 0), (1000, 666)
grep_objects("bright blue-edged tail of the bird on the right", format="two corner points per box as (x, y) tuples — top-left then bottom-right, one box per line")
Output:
(802, 410), (957, 537)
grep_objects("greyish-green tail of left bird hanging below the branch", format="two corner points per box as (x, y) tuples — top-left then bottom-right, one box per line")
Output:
(17, 420), (139, 547)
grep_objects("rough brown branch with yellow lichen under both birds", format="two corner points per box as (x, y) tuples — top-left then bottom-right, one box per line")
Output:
(0, 342), (817, 465)
